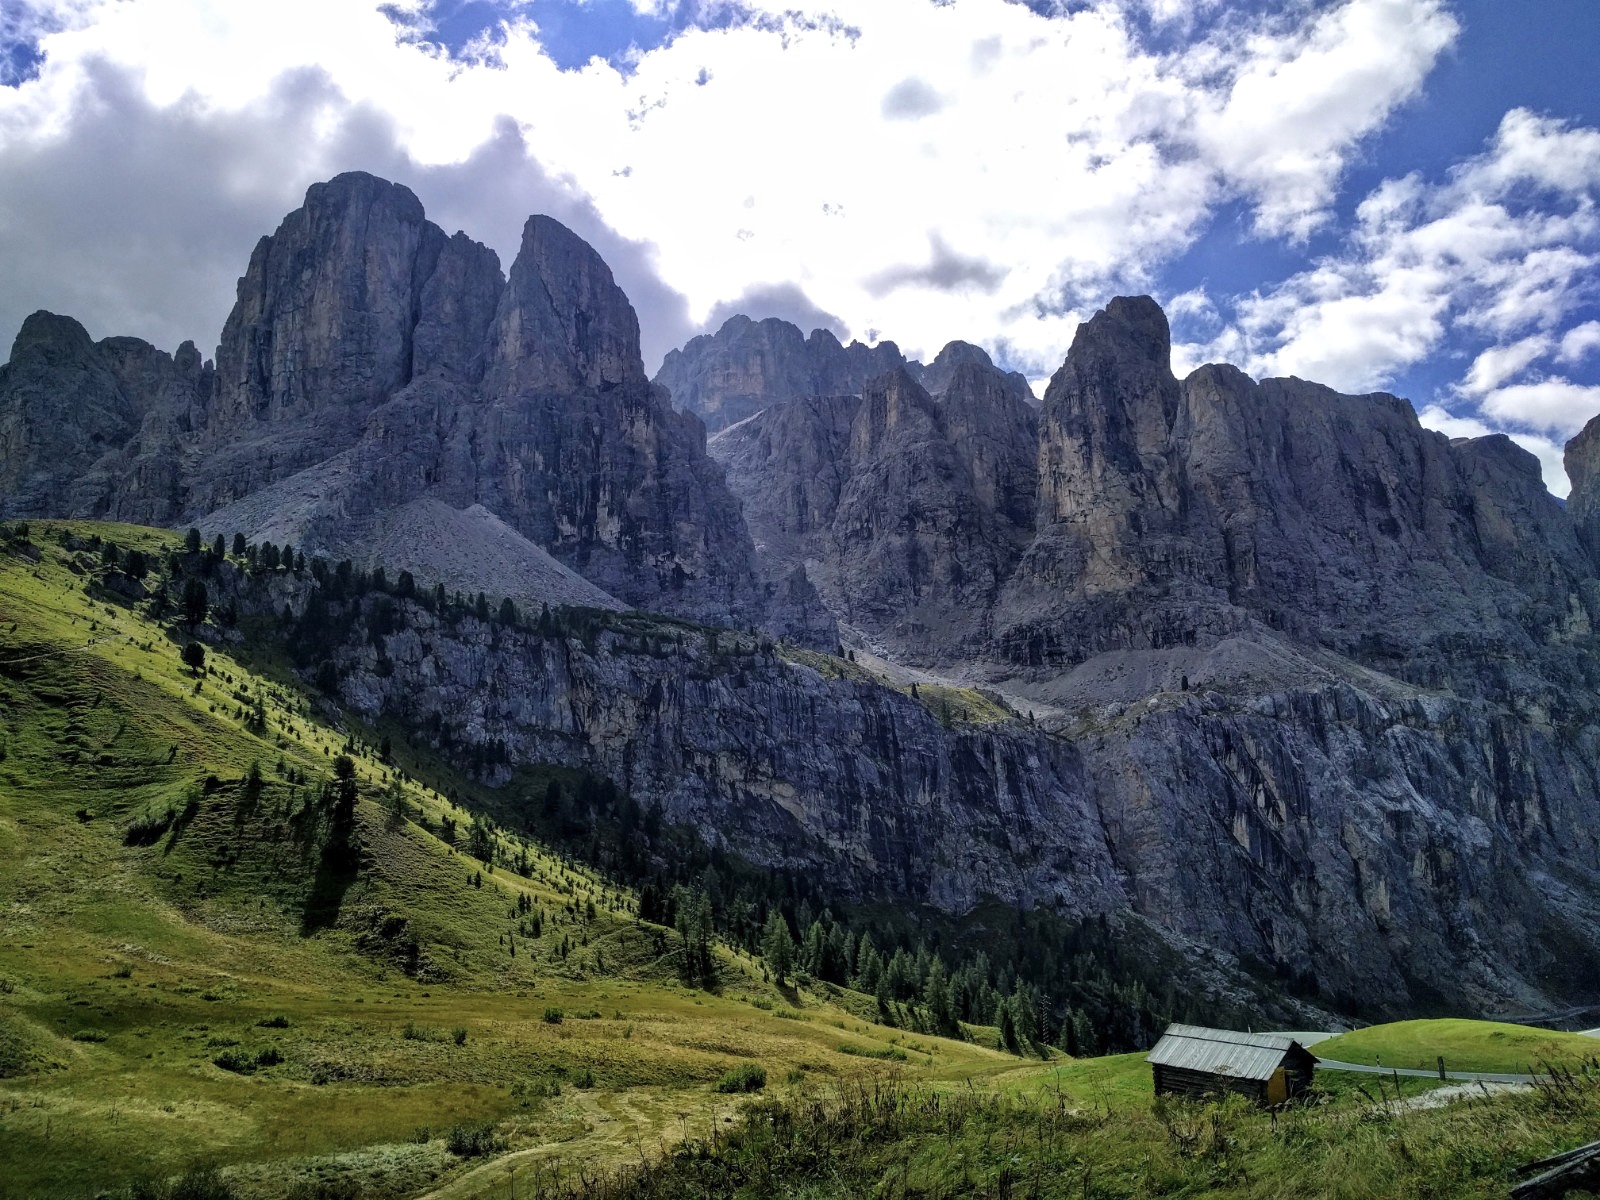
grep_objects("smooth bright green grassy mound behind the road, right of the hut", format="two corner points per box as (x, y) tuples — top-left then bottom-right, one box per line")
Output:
(1312, 1019), (1600, 1074)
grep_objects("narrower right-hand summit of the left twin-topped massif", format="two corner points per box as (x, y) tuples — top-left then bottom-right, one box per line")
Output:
(490, 216), (648, 392)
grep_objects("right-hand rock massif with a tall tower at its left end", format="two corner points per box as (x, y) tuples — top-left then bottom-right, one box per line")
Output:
(995, 301), (1600, 678)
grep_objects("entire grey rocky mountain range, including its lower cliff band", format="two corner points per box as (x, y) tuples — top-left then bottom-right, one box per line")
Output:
(0, 174), (1600, 1014)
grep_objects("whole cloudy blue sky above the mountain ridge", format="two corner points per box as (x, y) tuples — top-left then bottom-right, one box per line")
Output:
(0, 0), (1600, 494)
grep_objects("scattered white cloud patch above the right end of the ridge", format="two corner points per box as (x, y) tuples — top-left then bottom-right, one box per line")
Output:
(1218, 110), (1600, 390)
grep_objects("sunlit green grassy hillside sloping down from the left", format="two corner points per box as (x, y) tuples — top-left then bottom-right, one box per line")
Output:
(0, 523), (1016, 1197)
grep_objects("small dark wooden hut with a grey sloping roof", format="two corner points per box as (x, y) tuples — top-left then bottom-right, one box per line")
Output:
(1147, 1024), (1317, 1104)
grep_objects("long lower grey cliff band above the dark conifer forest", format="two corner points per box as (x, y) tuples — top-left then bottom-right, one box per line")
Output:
(209, 573), (1600, 1016)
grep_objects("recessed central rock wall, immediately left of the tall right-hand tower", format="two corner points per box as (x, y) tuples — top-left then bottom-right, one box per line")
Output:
(710, 360), (1037, 661)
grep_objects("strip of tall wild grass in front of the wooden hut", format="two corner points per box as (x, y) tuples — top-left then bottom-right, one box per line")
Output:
(541, 1070), (1600, 1200)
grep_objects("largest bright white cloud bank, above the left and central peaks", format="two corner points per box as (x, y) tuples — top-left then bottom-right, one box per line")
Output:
(0, 0), (1465, 374)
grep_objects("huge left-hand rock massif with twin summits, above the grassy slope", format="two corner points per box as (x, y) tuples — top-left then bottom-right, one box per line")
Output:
(0, 173), (835, 645)
